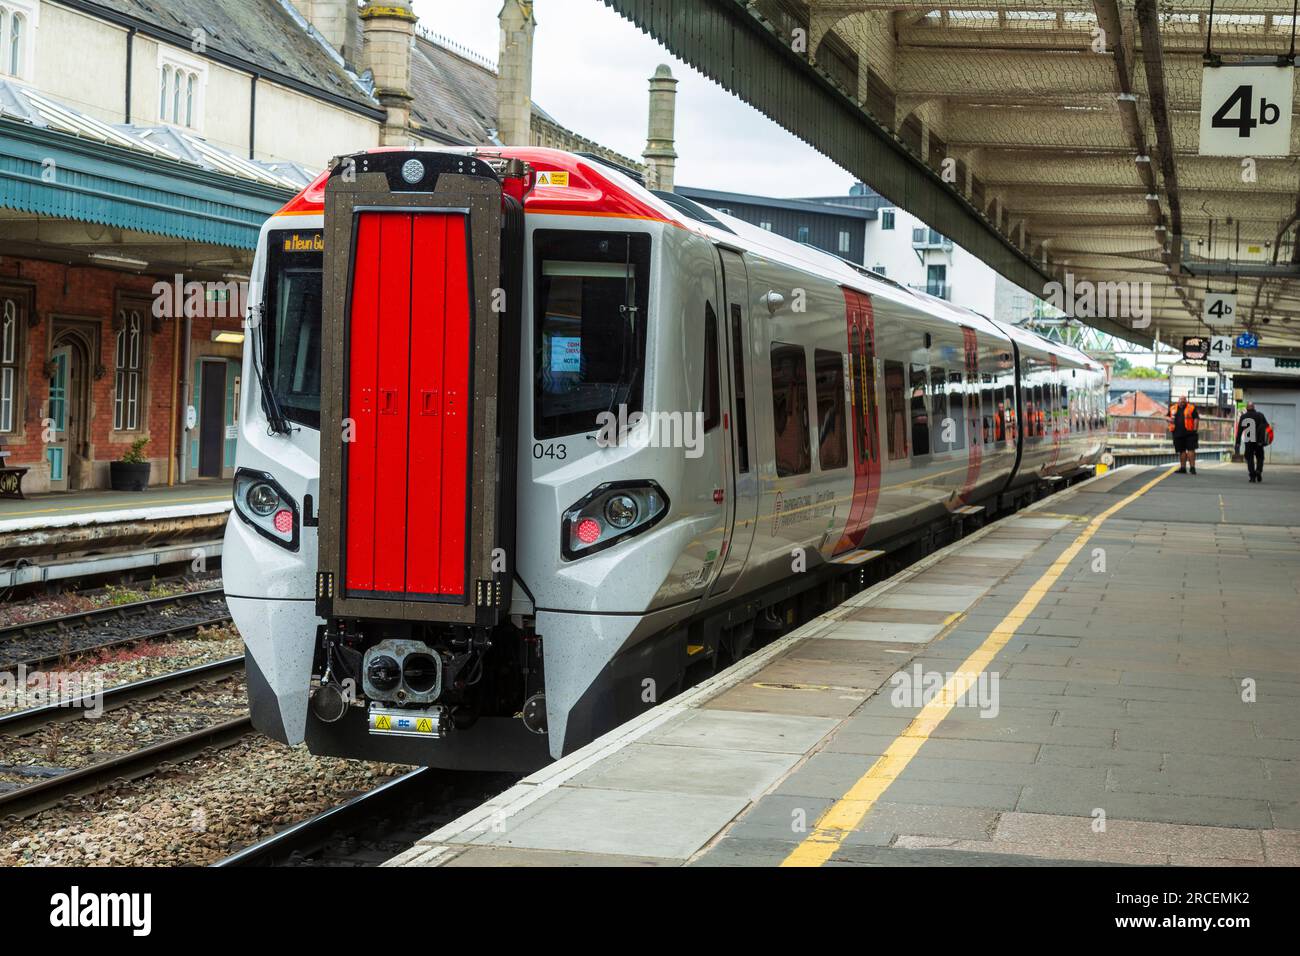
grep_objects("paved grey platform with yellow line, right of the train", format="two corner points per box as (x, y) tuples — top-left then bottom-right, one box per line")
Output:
(387, 464), (1300, 866)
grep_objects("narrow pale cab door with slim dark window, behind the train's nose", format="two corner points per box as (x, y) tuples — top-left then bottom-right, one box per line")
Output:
(710, 248), (758, 594)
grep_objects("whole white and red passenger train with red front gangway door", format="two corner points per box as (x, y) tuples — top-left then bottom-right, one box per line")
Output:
(224, 147), (1106, 771)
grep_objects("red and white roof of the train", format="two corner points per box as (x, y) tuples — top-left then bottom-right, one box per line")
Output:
(276, 146), (1100, 368)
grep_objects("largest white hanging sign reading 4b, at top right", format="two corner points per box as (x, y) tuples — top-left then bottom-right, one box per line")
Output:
(1200, 66), (1295, 156)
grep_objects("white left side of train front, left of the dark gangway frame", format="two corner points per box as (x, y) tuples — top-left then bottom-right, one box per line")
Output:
(222, 209), (324, 744)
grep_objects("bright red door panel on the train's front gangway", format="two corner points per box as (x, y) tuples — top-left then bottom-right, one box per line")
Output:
(343, 211), (471, 600)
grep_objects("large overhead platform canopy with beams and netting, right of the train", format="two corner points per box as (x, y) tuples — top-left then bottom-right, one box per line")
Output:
(605, 0), (1300, 354)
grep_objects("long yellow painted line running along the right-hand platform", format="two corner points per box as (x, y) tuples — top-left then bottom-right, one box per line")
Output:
(781, 467), (1174, 866)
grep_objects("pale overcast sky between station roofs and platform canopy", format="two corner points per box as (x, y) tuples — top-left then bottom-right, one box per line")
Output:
(415, 0), (853, 196)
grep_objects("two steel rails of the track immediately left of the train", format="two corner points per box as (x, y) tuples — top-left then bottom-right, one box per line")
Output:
(0, 656), (254, 821)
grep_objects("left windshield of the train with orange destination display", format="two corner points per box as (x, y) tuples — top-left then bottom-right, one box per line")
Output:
(257, 229), (325, 429)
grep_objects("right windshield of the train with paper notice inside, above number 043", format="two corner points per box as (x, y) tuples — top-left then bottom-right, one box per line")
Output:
(533, 229), (650, 438)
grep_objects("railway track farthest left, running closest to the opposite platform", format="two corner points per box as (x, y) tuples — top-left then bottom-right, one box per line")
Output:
(0, 588), (230, 671)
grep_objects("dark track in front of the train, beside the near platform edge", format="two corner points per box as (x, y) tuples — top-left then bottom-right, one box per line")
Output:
(213, 767), (519, 866)
